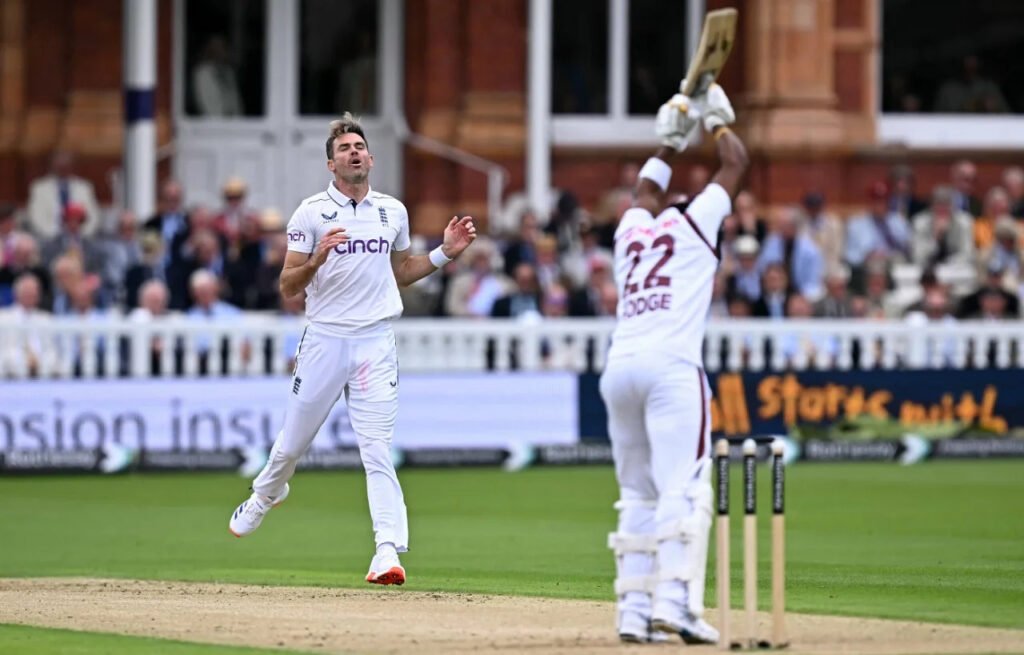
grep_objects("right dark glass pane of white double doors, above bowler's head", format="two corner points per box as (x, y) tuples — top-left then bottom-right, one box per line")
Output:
(299, 0), (380, 116)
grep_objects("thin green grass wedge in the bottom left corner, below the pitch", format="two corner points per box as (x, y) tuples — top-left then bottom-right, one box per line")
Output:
(0, 624), (311, 655)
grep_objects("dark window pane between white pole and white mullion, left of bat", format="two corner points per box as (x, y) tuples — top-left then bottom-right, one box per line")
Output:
(551, 0), (608, 114)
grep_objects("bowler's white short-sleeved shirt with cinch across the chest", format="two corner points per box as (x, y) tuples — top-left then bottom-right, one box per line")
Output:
(288, 181), (410, 337)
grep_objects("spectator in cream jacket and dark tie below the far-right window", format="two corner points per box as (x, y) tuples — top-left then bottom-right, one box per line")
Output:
(912, 186), (974, 268)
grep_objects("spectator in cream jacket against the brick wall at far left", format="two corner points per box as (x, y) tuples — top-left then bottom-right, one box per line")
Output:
(26, 150), (100, 242)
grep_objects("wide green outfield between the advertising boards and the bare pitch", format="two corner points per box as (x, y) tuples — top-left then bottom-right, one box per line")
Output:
(0, 462), (1024, 630)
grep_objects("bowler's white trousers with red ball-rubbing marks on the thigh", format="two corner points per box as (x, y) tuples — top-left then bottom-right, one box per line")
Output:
(253, 322), (409, 553)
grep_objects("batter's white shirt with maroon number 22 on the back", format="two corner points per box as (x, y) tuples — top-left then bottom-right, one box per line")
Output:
(608, 183), (732, 366)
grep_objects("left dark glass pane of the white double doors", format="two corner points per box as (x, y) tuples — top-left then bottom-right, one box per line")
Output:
(184, 0), (266, 118)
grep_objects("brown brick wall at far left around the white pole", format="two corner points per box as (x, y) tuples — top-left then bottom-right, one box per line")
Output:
(0, 0), (173, 204)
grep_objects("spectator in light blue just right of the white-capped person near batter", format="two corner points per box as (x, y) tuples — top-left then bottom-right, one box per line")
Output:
(758, 207), (824, 298)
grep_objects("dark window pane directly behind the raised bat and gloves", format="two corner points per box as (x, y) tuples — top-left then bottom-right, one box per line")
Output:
(627, 0), (689, 114)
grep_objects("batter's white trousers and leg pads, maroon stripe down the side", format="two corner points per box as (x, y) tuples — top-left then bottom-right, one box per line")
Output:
(600, 353), (711, 615)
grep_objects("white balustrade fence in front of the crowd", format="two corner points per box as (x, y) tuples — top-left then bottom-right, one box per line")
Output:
(0, 314), (1024, 380)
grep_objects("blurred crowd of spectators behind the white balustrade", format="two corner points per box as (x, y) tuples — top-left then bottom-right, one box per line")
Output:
(0, 147), (1024, 375)
